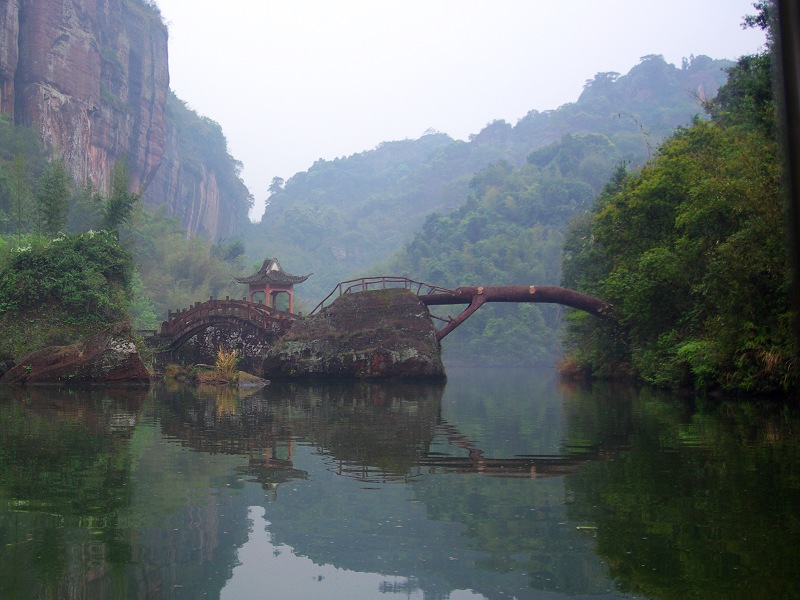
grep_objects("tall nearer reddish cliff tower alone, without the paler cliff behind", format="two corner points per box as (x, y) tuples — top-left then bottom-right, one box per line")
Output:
(10, 0), (169, 197)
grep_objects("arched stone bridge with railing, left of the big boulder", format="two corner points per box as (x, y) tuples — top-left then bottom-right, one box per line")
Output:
(158, 298), (299, 351)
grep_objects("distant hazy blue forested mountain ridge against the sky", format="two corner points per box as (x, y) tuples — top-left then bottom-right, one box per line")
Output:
(248, 55), (731, 307)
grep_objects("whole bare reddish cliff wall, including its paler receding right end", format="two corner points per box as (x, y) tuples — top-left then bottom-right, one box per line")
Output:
(0, 0), (249, 238)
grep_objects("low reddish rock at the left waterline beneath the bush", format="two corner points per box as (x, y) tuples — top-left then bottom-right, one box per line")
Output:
(0, 323), (150, 385)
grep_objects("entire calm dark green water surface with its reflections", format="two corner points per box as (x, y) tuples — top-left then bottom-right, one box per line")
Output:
(0, 371), (800, 600)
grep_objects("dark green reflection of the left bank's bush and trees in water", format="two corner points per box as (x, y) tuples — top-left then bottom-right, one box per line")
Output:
(0, 387), (146, 598)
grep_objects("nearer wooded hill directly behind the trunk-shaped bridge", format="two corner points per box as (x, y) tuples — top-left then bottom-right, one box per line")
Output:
(385, 134), (622, 366)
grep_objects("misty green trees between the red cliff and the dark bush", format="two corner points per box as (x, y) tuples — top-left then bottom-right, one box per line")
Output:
(0, 108), (252, 336)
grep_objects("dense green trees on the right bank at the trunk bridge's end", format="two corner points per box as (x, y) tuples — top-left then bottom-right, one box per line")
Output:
(564, 47), (797, 392)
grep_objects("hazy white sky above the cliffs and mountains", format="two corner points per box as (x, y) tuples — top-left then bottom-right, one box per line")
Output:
(152, 0), (764, 219)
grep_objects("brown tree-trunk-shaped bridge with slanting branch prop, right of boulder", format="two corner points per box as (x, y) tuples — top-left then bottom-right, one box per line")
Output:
(419, 285), (612, 341)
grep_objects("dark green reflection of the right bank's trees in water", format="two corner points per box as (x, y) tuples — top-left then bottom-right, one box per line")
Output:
(567, 388), (800, 598)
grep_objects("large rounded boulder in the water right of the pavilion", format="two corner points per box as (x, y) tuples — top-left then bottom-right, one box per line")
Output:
(263, 289), (445, 380)
